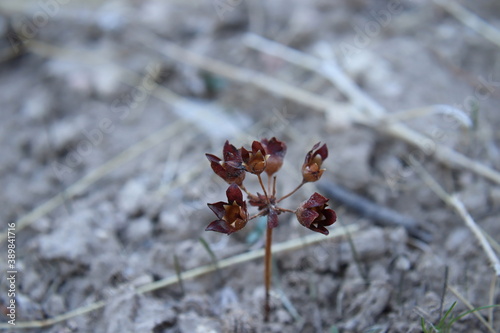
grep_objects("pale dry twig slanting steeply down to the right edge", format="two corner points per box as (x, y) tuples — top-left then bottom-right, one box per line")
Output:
(410, 158), (500, 276)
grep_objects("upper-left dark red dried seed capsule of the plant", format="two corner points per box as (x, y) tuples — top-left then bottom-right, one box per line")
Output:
(205, 141), (245, 186)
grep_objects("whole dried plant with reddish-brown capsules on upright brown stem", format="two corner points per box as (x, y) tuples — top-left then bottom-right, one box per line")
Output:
(205, 137), (337, 321)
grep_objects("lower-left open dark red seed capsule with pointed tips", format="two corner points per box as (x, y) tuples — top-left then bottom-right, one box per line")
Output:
(205, 184), (248, 235)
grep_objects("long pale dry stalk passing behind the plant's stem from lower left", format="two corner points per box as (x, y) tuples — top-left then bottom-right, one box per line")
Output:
(0, 224), (360, 329)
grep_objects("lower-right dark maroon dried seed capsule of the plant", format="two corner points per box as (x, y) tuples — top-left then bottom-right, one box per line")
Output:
(295, 192), (337, 235)
